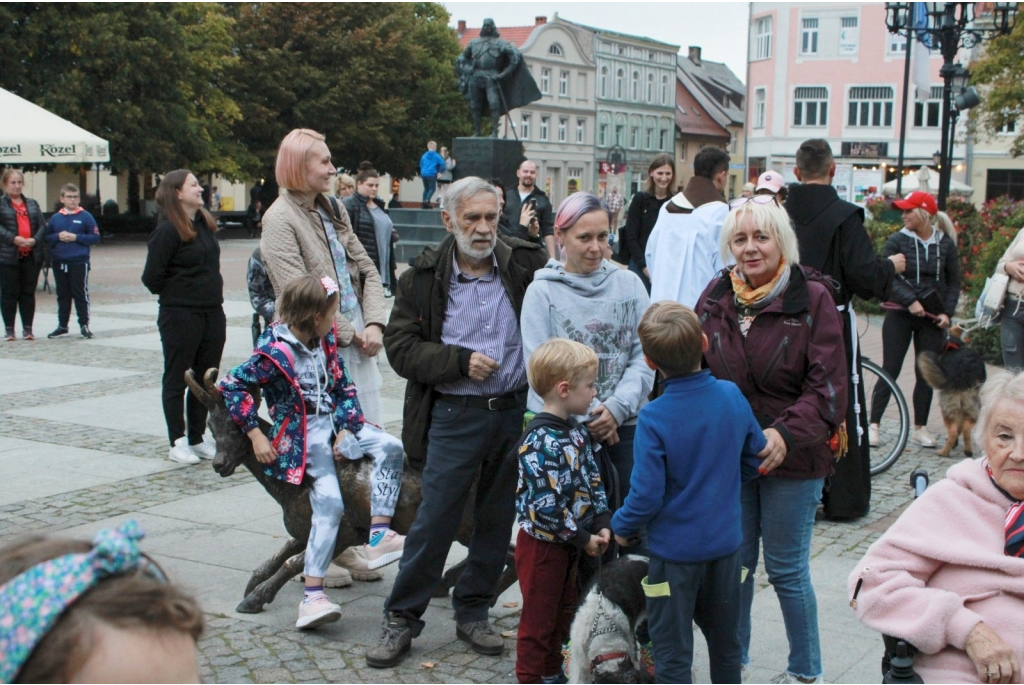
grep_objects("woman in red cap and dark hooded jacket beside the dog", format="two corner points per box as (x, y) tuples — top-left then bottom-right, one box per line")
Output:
(868, 191), (961, 447)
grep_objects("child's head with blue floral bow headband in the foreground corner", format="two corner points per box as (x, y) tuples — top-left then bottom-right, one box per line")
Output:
(0, 521), (203, 683)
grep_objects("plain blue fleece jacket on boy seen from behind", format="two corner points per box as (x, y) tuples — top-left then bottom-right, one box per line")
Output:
(611, 371), (766, 563)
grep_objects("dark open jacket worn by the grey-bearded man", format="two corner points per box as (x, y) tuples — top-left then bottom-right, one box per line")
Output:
(384, 234), (548, 469)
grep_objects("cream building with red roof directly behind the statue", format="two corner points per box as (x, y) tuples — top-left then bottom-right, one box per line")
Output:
(456, 16), (597, 207)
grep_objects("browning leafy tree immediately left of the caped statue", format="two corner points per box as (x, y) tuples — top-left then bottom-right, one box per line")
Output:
(226, 2), (472, 177)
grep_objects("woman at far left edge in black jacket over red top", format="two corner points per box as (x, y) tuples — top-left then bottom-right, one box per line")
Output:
(0, 169), (46, 342)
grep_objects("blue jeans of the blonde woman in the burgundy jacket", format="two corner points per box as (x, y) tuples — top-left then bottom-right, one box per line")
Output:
(739, 476), (824, 678)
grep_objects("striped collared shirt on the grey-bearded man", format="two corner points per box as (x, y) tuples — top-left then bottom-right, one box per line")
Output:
(434, 254), (526, 397)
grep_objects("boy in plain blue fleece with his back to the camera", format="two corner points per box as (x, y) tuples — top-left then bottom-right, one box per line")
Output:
(611, 301), (767, 683)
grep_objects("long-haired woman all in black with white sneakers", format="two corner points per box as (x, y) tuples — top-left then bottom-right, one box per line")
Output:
(142, 169), (226, 464)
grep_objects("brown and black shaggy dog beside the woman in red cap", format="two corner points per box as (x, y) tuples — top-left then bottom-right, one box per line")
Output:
(918, 327), (985, 457)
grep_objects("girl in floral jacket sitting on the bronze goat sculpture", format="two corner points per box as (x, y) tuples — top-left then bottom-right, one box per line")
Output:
(220, 274), (406, 629)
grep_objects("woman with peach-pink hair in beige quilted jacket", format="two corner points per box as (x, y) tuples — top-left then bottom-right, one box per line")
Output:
(260, 128), (387, 587)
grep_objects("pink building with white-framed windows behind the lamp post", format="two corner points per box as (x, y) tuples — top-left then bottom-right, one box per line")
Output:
(746, 2), (965, 203)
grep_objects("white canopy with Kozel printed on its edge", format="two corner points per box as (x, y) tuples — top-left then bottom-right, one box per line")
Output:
(0, 88), (111, 165)
